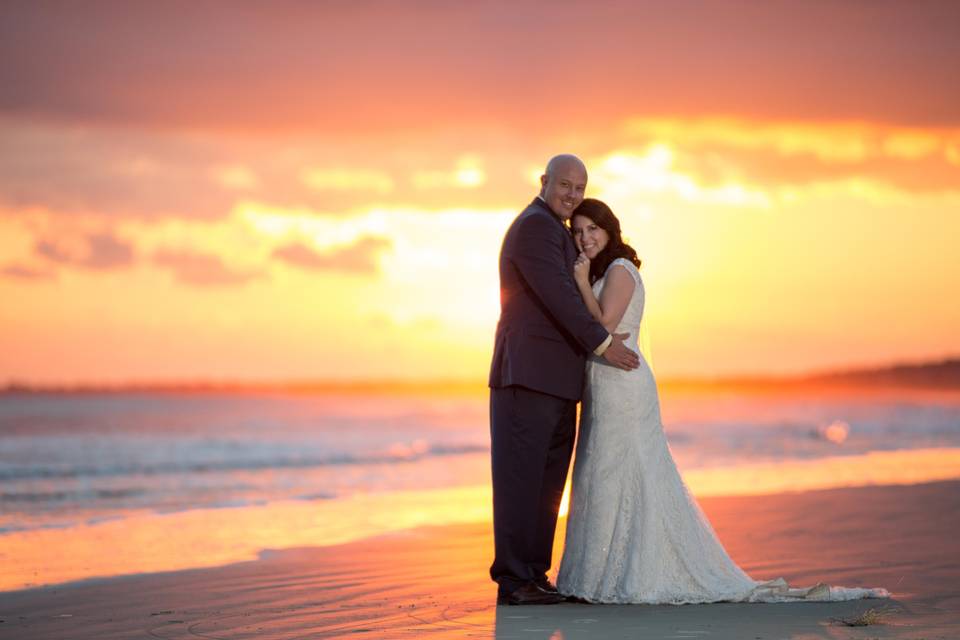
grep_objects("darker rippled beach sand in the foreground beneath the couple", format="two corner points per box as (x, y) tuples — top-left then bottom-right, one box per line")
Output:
(0, 481), (960, 640)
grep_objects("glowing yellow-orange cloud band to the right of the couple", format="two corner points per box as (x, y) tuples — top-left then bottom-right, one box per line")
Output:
(626, 118), (960, 192)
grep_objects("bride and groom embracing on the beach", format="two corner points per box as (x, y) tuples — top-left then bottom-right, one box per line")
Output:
(489, 155), (889, 605)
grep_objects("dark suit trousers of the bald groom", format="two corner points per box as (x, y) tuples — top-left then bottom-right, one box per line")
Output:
(490, 386), (577, 591)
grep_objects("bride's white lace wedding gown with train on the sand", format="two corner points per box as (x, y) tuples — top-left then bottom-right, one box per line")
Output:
(557, 259), (889, 604)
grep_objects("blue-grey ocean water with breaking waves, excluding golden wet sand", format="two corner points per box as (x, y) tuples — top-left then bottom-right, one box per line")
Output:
(0, 384), (960, 535)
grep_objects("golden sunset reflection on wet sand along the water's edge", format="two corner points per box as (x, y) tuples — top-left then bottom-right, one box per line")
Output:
(0, 449), (960, 591)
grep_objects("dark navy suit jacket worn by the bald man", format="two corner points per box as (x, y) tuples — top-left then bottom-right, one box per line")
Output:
(489, 198), (608, 400)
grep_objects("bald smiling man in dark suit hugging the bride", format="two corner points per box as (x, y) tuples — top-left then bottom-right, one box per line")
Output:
(489, 154), (639, 604)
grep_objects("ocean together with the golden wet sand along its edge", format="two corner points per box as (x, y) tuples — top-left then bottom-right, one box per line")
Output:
(0, 389), (960, 590)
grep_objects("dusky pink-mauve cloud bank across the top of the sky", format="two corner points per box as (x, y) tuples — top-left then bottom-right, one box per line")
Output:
(0, 0), (960, 135)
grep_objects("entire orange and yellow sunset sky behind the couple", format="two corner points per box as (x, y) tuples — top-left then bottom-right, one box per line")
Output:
(0, 1), (960, 384)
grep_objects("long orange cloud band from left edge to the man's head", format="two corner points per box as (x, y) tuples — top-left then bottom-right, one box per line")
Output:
(0, 120), (536, 224)
